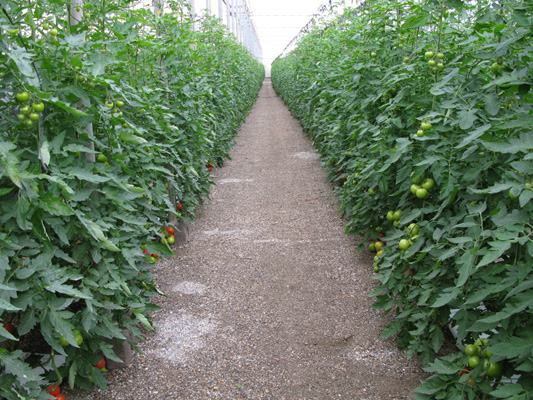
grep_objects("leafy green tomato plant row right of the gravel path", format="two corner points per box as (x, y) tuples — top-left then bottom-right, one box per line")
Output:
(272, 0), (533, 399)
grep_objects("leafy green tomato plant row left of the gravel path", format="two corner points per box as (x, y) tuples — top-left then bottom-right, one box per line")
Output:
(0, 0), (264, 399)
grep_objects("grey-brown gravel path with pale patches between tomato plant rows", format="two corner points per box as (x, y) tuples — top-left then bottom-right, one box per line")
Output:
(67, 80), (423, 400)
